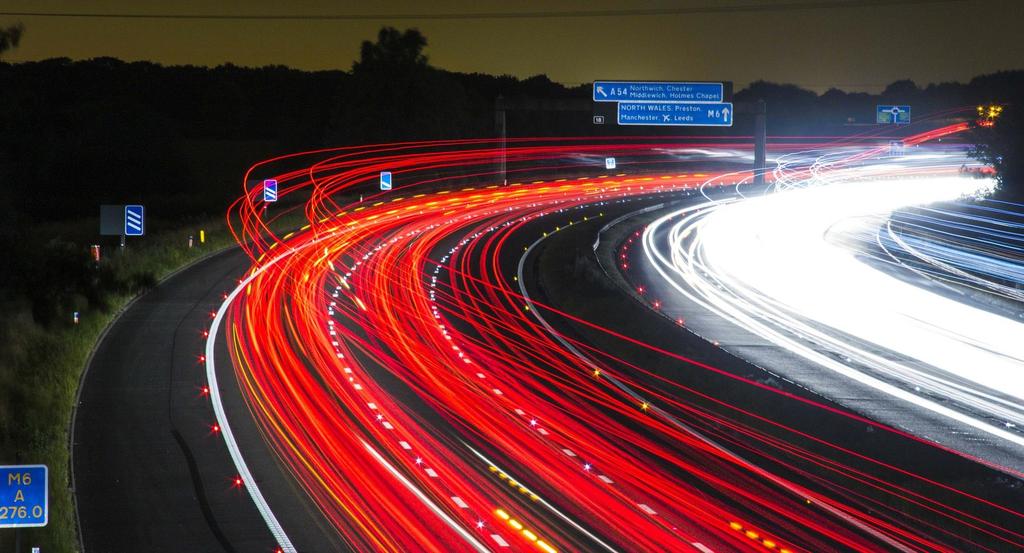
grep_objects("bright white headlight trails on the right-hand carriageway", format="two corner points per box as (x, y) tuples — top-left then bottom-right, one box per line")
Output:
(643, 152), (1024, 445)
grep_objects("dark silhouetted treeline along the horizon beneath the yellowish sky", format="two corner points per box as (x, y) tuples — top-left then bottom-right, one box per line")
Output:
(0, 28), (1024, 327)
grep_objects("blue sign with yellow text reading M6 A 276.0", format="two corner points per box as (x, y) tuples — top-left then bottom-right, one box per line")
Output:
(0, 465), (50, 528)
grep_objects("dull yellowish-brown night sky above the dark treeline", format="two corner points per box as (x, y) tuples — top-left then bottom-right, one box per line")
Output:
(0, 0), (1024, 92)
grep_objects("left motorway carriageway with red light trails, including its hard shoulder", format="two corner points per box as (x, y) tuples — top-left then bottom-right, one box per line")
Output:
(75, 132), (1024, 553)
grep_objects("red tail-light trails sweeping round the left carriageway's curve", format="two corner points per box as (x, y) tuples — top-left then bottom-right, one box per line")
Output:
(207, 130), (1024, 553)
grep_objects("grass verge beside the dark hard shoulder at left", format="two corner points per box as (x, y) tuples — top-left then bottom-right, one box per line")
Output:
(0, 208), (303, 552)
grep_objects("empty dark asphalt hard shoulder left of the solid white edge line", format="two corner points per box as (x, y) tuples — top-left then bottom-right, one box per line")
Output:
(73, 250), (272, 552)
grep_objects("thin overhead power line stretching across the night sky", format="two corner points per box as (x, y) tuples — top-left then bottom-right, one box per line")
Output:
(0, 0), (967, 22)
